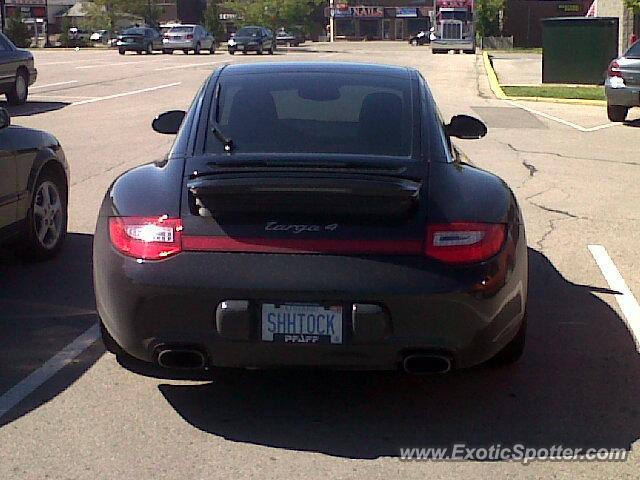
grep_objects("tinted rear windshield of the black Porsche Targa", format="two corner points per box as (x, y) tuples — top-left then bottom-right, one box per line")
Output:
(207, 73), (413, 156)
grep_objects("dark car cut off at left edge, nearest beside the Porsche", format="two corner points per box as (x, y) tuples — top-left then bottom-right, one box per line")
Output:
(0, 108), (69, 259)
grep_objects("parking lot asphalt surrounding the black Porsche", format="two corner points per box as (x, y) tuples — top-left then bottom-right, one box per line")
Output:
(0, 42), (640, 479)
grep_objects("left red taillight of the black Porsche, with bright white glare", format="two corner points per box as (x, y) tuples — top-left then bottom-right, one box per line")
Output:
(109, 216), (182, 260)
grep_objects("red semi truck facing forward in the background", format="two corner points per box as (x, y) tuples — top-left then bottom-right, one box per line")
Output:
(431, 0), (476, 53)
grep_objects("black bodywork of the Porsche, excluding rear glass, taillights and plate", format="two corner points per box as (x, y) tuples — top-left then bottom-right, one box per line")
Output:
(94, 63), (528, 369)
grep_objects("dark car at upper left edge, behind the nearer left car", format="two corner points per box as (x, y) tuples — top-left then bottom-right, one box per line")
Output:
(0, 32), (38, 105)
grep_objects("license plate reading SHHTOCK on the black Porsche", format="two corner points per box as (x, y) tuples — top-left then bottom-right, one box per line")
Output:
(262, 303), (342, 345)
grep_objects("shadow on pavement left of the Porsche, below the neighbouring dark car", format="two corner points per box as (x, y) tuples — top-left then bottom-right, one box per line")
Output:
(0, 234), (104, 427)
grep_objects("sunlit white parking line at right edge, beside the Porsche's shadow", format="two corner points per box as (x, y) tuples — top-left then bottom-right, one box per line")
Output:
(589, 245), (640, 352)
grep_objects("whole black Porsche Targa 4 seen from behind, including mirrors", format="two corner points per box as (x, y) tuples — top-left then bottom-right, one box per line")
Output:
(93, 63), (527, 373)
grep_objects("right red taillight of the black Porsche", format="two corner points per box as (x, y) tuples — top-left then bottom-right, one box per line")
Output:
(425, 222), (507, 264)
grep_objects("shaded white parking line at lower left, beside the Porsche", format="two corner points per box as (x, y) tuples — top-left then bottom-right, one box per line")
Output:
(0, 324), (100, 418)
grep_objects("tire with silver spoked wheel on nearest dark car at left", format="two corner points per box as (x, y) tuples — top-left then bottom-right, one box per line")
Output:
(22, 167), (68, 260)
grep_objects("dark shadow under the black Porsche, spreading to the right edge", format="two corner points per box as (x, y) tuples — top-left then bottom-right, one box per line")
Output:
(159, 250), (640, 459)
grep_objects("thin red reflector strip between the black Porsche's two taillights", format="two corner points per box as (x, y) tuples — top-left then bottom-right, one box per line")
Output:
(182, 236), (423, 255)
